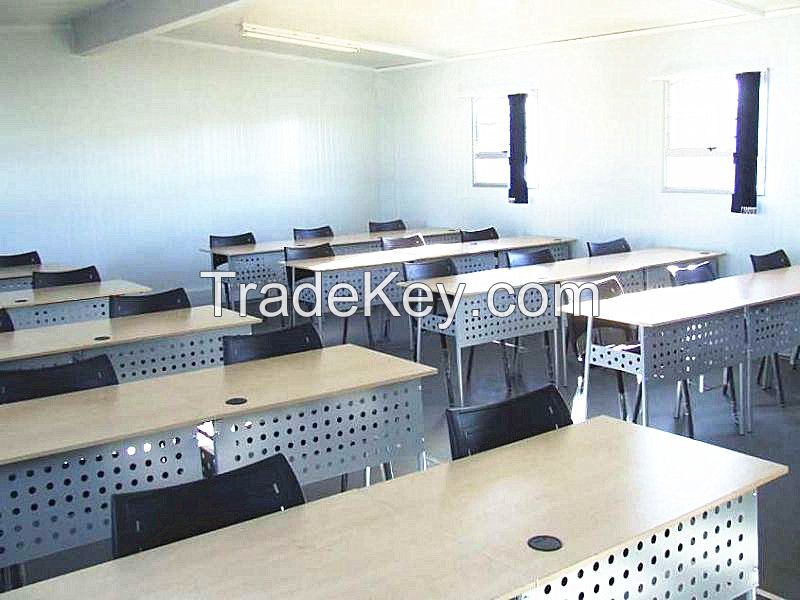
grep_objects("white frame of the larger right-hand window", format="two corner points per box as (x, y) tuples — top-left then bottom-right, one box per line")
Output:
(661, 69), (769, 197)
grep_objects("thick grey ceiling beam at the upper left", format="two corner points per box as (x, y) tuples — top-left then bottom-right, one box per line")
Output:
(71, 0), (243, 54)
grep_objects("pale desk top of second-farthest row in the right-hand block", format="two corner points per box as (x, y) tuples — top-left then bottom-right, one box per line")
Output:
(286, 236), (574, 273)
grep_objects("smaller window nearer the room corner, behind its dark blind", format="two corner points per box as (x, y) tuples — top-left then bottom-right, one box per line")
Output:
(472, 92), (538, 188)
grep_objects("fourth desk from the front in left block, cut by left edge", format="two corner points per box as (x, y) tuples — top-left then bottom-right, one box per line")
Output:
(0, 280), (152, 329)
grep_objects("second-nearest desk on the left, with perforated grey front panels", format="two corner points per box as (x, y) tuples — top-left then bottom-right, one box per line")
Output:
(0, 345), (436, 567)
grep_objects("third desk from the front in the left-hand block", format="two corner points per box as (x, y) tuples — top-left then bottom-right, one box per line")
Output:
(0, 306), (261, 382)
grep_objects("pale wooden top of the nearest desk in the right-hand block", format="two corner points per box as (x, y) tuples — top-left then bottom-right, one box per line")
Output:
(562, 267), (800, 327)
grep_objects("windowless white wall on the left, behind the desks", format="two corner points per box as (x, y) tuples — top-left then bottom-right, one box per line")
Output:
(0, 31), (377, 298)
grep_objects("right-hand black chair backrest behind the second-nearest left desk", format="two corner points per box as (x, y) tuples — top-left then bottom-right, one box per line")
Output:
(222, 323), (322, 365)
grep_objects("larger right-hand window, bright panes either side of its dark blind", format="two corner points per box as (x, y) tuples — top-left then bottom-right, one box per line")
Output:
(664, 74), (767, 195)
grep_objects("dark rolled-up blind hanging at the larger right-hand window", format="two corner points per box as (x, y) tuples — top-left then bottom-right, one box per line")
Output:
(731, 73), (761, 215)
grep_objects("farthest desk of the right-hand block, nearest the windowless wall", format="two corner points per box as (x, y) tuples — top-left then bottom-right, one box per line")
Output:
(201, 227), (460, 288)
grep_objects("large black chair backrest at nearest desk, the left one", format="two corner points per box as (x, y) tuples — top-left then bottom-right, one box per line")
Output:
(111, 454), (305, 558)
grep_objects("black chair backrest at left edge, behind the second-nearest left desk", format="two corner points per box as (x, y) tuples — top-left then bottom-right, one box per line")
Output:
(0, 354), (118, 404)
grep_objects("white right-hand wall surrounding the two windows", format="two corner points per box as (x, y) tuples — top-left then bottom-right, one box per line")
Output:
(377, 16), (800, 273)
